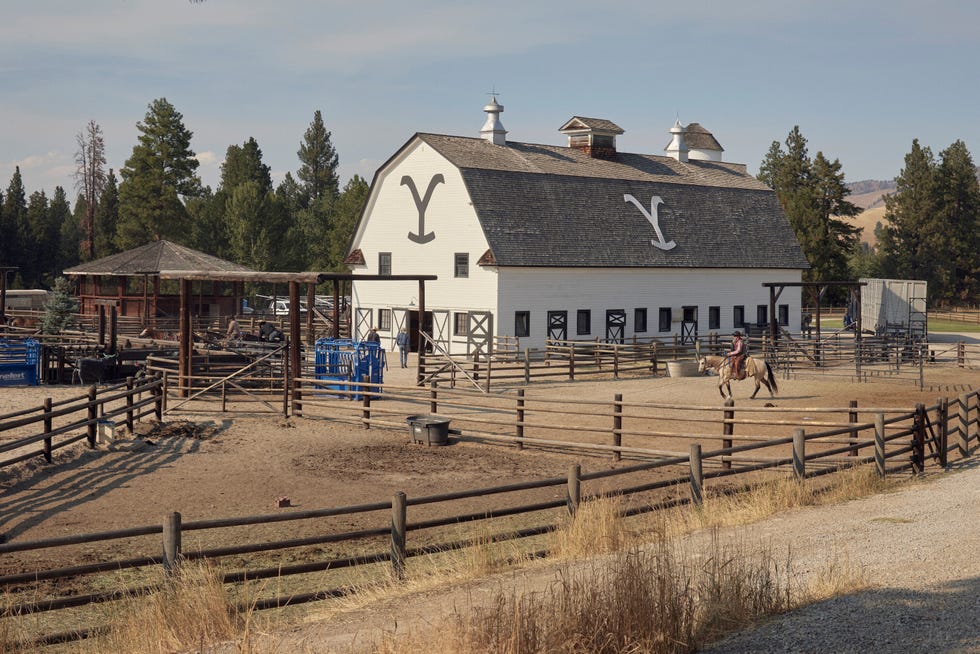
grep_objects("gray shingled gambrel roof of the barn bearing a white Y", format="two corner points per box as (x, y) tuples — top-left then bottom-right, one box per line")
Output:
(417, 134), (810, 269)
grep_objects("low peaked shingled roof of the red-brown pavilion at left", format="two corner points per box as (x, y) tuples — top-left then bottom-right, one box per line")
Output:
(64, 240), (255, 277)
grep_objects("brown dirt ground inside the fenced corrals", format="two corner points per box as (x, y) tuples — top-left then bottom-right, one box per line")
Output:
(0, 368), (980, 542)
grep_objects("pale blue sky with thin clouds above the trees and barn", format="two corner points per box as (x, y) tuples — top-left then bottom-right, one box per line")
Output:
(0, 0), (980, 197)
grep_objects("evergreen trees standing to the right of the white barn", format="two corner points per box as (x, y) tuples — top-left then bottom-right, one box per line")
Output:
(758, 126), (980, 305)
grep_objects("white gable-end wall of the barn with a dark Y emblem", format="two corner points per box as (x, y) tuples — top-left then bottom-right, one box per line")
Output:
(352, 141), (497, 352)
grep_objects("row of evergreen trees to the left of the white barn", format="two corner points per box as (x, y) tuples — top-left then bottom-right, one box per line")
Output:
(0, 98), (368, 288)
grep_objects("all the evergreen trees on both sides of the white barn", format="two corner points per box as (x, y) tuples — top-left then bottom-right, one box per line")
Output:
(0, 105), (980, 310)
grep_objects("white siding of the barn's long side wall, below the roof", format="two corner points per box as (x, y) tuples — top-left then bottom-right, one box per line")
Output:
(495, 268), (801, 348)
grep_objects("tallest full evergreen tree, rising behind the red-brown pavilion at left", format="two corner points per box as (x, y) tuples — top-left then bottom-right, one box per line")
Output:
(116, 98), (201, 250)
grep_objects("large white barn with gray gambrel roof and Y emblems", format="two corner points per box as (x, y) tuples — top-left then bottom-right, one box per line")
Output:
(346, 98), (809, 353)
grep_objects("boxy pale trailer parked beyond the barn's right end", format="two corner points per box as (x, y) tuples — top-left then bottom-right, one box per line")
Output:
(858, 278), (929, 339)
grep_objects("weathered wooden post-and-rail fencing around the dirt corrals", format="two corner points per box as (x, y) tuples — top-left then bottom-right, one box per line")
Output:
(0, 378), (980, 645)
